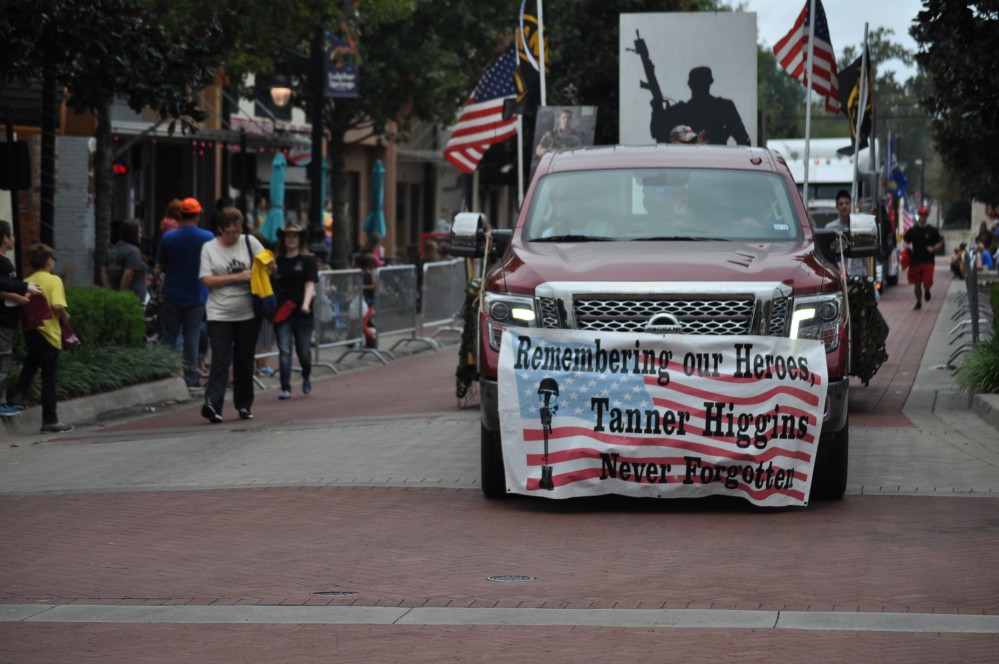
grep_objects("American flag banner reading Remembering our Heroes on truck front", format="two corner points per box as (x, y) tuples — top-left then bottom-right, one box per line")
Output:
(499, 329), (827, 506)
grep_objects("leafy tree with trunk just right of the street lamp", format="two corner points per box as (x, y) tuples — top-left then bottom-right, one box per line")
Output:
(219, 0), (515, 268)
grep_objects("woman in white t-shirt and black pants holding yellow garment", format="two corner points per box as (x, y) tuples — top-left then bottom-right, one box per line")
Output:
(199, 207), (274, 424)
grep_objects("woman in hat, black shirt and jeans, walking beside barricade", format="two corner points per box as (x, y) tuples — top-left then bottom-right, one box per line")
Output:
(273, 224), (319, 399)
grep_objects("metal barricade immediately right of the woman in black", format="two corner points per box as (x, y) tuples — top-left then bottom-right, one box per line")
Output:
(312, 270), (388, 373)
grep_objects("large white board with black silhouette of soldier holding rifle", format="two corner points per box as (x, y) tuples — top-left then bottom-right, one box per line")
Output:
(618, 12), (757, 145)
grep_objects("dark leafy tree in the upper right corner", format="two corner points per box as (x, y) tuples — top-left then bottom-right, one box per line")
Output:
(911, 0), (999, 204)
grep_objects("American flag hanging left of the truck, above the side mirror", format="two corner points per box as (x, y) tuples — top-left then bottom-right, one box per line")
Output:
(444, 49), (517, 173)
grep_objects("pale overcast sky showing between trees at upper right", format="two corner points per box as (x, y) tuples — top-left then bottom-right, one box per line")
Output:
(730, 0), (923, 83)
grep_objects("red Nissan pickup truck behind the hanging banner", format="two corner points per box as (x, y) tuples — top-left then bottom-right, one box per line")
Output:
(451, 145), (877, 503)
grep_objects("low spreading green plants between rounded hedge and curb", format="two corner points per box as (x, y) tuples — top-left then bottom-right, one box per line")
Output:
(9, 342), (183, 403)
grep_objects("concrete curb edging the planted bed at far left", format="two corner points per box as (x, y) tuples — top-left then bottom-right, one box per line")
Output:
(0, 376), (191, 436)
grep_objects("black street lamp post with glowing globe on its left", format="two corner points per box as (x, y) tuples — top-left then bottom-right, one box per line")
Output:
(271, 26), (326, 252)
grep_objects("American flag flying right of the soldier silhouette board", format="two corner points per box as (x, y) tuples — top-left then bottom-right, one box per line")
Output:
(774, 0), (840, 113)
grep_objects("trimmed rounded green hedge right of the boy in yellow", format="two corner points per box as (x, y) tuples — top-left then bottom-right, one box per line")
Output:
(66, 286), (146, 348)
